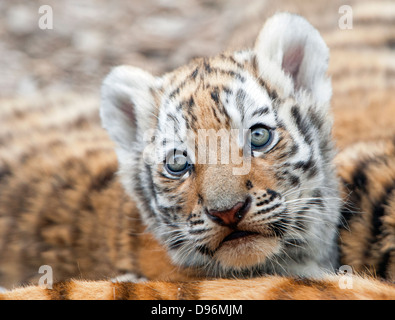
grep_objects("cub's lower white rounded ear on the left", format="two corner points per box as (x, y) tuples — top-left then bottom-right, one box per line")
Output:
(100, 66), (158, 152)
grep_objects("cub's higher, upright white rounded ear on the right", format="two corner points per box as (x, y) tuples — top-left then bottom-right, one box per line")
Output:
(255, 13), (332, 102)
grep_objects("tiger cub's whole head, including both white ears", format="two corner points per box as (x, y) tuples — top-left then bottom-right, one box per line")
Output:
(101, 14), (338, 275)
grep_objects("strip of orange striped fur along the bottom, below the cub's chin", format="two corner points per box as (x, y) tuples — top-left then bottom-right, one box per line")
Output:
(0, 275), (395, 300)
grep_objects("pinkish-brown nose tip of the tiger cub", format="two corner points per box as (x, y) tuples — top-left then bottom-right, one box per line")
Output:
(207, 198), (251, 227)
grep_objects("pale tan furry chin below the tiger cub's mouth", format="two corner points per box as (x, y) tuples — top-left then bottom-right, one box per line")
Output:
(213, 235), (280, 271)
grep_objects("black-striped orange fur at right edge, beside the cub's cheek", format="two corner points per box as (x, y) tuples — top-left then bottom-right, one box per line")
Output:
(336, 139), (395, 281)
